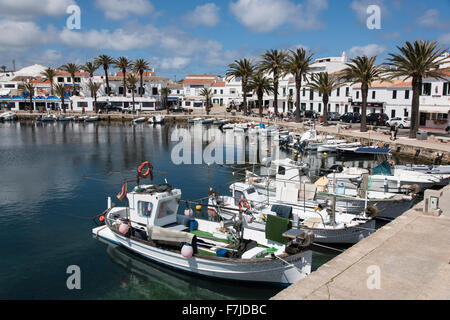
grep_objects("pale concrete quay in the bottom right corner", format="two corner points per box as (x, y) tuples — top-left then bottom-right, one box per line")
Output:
(272, 185), (450, 300)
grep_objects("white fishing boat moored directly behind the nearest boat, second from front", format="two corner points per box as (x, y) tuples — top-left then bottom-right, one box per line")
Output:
(208, 183), (377, 244)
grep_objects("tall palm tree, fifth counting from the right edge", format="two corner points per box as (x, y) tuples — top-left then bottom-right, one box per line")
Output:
(259, 49), (287, 115)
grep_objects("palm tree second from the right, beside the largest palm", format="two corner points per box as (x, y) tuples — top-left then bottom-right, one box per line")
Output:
(341, 55), (382, 132)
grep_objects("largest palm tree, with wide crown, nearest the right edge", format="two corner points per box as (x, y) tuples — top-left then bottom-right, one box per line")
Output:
(384, 40), (446, 139)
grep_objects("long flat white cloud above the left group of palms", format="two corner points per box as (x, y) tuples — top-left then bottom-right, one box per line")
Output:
(59, 25), (159, 51)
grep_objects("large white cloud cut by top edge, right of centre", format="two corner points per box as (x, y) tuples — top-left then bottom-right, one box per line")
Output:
(230, 0), (328, 32)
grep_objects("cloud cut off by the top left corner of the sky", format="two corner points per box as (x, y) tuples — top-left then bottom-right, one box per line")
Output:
(0, 0), (75, 19)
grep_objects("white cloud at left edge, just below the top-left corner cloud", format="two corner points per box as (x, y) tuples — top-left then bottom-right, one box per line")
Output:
(0, 19), (57, 51)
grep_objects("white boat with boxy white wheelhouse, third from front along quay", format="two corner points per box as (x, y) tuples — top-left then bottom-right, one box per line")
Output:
(245, 159), (417, 219)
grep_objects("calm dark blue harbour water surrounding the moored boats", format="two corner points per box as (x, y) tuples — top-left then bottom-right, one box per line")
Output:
(0, 123), (408, 299)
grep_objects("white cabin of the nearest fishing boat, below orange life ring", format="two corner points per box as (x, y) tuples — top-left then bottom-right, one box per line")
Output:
(127, 185), (181, 230)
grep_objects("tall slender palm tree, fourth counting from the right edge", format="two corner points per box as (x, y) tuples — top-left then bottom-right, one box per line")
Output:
(285, 48), (314, 122)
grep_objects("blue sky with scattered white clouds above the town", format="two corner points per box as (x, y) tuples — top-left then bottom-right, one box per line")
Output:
(0, 0), (450, 79)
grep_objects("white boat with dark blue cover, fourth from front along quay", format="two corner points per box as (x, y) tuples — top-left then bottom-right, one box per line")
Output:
(327, 161), (442, 193)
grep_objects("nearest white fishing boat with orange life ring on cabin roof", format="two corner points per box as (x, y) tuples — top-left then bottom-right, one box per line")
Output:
(92, 165), (312, 285)
